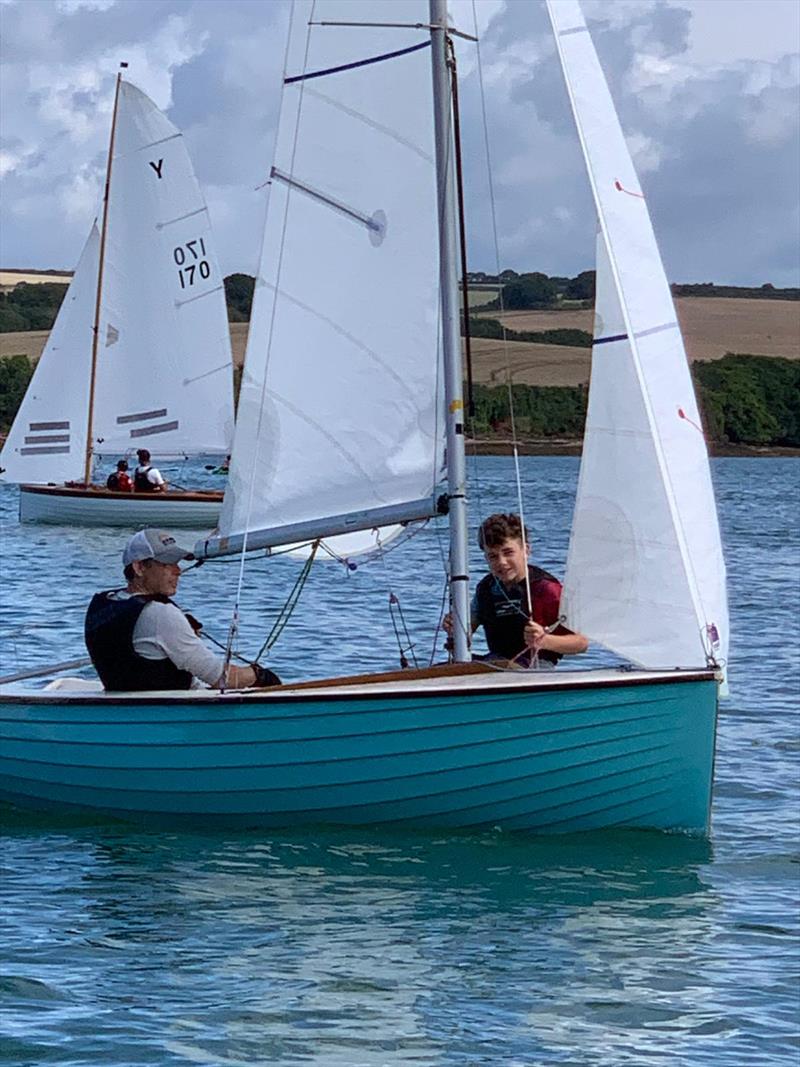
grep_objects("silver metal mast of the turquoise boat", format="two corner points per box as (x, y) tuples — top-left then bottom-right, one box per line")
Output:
(430, 0), (470, 663)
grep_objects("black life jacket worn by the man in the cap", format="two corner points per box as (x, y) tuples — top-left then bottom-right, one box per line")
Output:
(84, 589), (192, 692)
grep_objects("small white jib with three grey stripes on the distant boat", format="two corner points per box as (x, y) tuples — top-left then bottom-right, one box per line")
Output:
(0, 224), (100, 484)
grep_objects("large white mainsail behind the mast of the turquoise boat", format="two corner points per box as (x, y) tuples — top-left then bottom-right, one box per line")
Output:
(208, 0), (444, 552)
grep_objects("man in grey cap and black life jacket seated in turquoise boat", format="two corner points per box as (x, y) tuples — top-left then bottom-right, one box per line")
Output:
(84, 529), (281, 691)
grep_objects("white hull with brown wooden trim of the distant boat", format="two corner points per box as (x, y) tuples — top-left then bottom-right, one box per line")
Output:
(19, 485), (223, 529)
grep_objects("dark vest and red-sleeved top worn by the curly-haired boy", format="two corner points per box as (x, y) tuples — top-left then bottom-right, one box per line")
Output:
(475, 566), (561, 664)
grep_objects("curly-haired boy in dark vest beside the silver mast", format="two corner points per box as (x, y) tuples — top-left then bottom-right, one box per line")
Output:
(443, 514), (589, 670)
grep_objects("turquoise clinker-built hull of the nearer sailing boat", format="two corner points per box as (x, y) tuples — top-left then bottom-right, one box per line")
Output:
(0, 668), (717, 833)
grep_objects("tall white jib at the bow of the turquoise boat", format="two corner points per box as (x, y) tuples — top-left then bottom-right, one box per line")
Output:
(548, 0), (729, 668)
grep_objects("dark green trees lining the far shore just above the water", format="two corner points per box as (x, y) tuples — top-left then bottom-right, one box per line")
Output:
(0, 353), (800, 448)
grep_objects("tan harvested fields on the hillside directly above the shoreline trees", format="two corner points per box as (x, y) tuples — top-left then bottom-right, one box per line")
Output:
(0, 297), (800, 385)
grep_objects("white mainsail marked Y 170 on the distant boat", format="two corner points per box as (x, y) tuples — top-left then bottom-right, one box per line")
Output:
(93, 81), (234, 455)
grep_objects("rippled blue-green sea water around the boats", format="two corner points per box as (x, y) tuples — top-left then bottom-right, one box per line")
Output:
(0, 458), (800, 1067)
